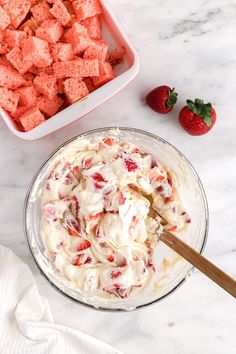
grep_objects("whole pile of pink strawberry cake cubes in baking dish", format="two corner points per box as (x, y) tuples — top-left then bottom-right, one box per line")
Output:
(0, 0), (125, 131)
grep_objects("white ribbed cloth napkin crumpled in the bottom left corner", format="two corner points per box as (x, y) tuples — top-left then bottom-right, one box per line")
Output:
(0, 246), (121, 354)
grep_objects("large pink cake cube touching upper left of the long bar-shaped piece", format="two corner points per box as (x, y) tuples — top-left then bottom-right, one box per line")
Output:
(22, 37), (52, 68)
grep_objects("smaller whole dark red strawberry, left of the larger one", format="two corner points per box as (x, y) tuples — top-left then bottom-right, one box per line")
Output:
(146, 86), (178, 114)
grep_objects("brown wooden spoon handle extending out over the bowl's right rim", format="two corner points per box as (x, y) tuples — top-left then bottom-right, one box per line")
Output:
(160, 230), (236, 298)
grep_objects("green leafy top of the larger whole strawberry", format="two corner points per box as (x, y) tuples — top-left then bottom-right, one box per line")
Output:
(186, 98), (212, 127)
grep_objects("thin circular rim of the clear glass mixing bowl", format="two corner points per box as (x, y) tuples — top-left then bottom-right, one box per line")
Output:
(23, 126), (209, 313)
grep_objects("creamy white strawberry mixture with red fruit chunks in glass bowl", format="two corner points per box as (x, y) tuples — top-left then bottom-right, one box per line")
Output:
(41, 134), (191, 299)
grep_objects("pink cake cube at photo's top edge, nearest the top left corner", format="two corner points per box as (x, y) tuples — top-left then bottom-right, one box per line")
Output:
(4, 0), (31, 28)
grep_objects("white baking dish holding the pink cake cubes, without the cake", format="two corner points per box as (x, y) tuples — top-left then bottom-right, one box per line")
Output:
(0, 0), (140, 140)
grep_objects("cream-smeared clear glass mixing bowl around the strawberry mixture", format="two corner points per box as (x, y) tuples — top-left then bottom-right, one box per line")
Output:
(24, 128), (208, 311)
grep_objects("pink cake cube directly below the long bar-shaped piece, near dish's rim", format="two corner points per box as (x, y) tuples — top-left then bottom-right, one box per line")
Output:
(63, 78), (89, 104)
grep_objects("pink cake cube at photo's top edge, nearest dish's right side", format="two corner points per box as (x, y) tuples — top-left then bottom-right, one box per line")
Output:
(72, 0), (102, 22)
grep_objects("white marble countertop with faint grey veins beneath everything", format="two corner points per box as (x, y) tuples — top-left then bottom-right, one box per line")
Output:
(0, 0), (236, 354)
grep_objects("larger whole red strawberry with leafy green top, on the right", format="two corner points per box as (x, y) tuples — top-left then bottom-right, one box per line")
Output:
(179, 98), (216, 135)
